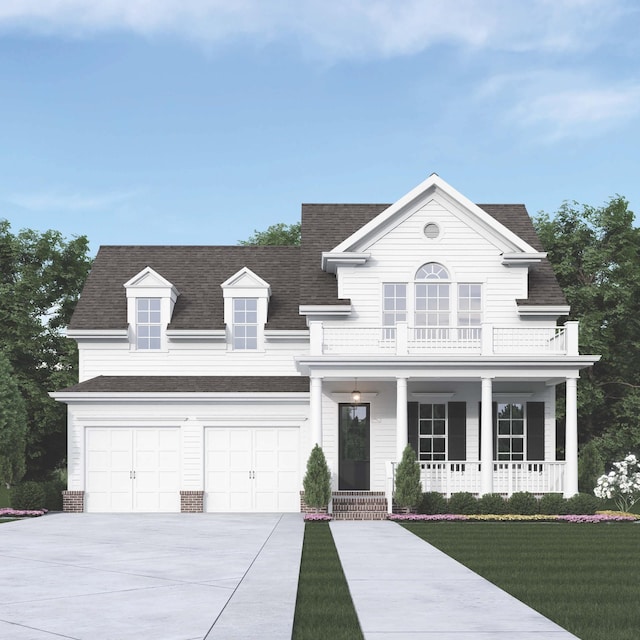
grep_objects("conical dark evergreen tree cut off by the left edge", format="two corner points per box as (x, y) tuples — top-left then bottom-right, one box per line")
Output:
(0, 351), (27, 487)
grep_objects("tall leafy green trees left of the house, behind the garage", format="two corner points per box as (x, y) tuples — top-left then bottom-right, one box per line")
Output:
(0, 220), (91, 478)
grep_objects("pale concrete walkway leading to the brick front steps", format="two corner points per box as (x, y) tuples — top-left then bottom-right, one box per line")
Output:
(331, 521), (576, 640)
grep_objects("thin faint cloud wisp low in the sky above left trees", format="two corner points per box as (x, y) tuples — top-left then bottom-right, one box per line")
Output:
(5, 191), (138, 213)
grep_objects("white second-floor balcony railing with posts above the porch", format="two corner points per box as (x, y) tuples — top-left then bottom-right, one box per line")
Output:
(309, 322), (578, 356)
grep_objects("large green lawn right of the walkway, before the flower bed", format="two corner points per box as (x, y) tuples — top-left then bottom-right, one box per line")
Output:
(402, 522), (640, 640)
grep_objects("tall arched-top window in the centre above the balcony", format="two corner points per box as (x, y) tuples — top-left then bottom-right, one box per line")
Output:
(415, 262), (450, 340)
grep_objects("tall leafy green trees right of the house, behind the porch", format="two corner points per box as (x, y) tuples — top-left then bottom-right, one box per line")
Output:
(535, 196), (640, 462)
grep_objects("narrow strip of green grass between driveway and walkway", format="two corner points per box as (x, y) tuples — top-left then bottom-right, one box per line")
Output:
(292, 522), (363, 640)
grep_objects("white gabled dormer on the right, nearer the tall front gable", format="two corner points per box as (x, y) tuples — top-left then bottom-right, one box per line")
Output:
(220, 267), (271, 352)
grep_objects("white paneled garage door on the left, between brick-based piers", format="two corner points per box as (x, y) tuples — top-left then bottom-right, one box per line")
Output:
(85, 427), (180, 513)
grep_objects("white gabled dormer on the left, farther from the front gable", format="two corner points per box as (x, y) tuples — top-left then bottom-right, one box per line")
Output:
(124, 267), (180, 351)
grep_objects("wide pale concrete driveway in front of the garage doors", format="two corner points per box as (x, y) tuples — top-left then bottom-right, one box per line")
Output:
(0, 513), (304, 640)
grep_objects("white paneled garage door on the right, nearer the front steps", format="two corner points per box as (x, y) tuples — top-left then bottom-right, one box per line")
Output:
(205, 427), (300, 512)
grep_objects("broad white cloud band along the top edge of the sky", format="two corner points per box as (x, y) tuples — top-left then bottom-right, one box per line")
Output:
(0, 0), (634, 59)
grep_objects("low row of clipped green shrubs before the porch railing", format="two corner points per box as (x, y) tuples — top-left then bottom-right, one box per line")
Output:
(418, 491), (602, 515)
